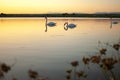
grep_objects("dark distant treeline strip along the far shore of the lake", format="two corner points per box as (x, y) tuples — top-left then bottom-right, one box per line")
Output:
(0, 13), (120, 18)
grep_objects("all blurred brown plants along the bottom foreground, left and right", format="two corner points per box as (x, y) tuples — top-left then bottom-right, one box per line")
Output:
(0, 41), (120, 80)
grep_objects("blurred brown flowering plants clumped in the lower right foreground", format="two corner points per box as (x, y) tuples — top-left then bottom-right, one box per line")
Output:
(66, 41), (120, 80)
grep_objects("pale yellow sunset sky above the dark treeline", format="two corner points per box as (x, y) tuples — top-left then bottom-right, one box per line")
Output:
(0, 0), (120, 14)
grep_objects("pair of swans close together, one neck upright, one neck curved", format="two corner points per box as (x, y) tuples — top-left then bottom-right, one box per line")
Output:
(45, 17), (76, 32)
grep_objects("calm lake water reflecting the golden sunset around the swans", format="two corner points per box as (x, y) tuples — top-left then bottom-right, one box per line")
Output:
(0, 18), (120, 80)
